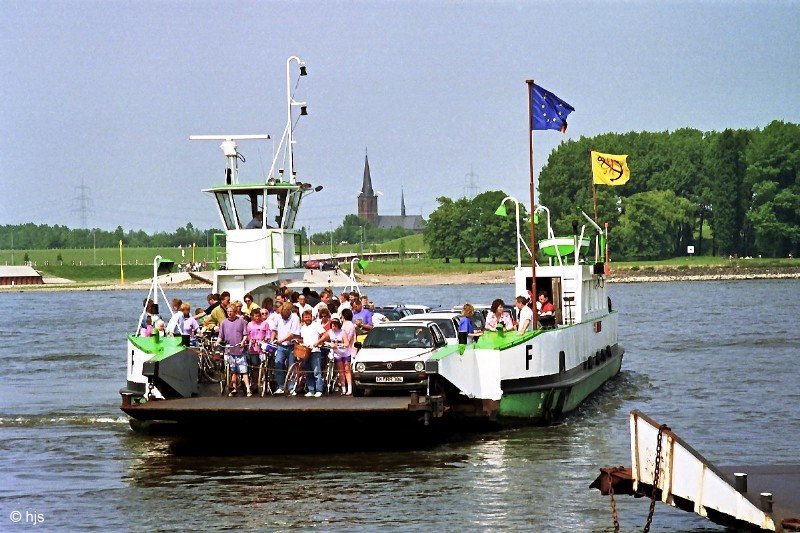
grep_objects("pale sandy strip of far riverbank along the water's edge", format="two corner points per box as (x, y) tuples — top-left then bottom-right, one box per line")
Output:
(0, 264), (800, 293)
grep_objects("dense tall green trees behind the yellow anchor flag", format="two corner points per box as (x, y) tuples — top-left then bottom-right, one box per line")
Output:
(539, 121), (800, 259)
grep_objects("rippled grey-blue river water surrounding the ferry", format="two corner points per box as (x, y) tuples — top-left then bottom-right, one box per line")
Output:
(0, 280), (800, 531)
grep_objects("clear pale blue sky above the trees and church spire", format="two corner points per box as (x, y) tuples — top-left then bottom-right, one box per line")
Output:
(0, 1), (800, 232)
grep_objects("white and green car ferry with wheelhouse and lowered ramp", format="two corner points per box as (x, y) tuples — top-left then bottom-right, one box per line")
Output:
(120, 61), (623, 438)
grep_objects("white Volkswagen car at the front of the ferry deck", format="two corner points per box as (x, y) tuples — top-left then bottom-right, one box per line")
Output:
(352, 317), (447, 396)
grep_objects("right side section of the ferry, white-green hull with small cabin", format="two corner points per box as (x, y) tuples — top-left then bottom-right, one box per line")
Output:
(426, 214), (624, 424)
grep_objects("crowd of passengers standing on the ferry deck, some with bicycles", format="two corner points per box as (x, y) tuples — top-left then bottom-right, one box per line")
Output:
(139, 287), (553, 398)
